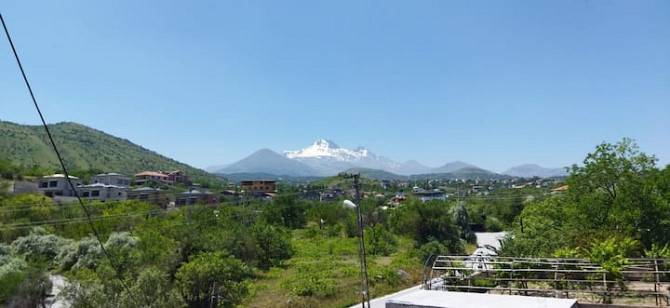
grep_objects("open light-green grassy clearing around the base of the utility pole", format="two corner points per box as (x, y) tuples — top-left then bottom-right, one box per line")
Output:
(248, 227), (422, 307)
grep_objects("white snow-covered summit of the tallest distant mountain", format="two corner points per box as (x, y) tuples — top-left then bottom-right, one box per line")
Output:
(284, 139), (370, 162)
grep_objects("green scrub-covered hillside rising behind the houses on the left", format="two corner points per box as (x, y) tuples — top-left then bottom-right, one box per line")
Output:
(0, 121), (220, 181)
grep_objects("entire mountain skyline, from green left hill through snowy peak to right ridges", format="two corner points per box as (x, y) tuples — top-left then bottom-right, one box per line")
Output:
(0, 121), (566, 181)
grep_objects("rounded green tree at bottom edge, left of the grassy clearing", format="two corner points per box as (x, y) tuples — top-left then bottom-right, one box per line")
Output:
(176, 251), (251, 307)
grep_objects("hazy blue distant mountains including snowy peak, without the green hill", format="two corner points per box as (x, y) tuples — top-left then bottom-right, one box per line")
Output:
(213, 139), (566, 177)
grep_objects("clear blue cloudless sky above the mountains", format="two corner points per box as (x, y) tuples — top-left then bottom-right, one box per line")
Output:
(0, 0), (670, 172)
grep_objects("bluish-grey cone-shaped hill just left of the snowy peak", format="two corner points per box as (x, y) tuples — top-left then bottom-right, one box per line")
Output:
(216, 149), (317, 176)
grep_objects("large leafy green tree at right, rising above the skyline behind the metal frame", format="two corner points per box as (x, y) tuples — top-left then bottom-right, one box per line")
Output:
(566, 138), (670, 248)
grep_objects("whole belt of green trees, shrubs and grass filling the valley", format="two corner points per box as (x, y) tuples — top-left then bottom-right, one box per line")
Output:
(0, 139), (670, 307)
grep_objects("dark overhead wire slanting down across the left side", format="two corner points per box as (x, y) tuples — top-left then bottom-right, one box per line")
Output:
(0, 14), (140, 306)
